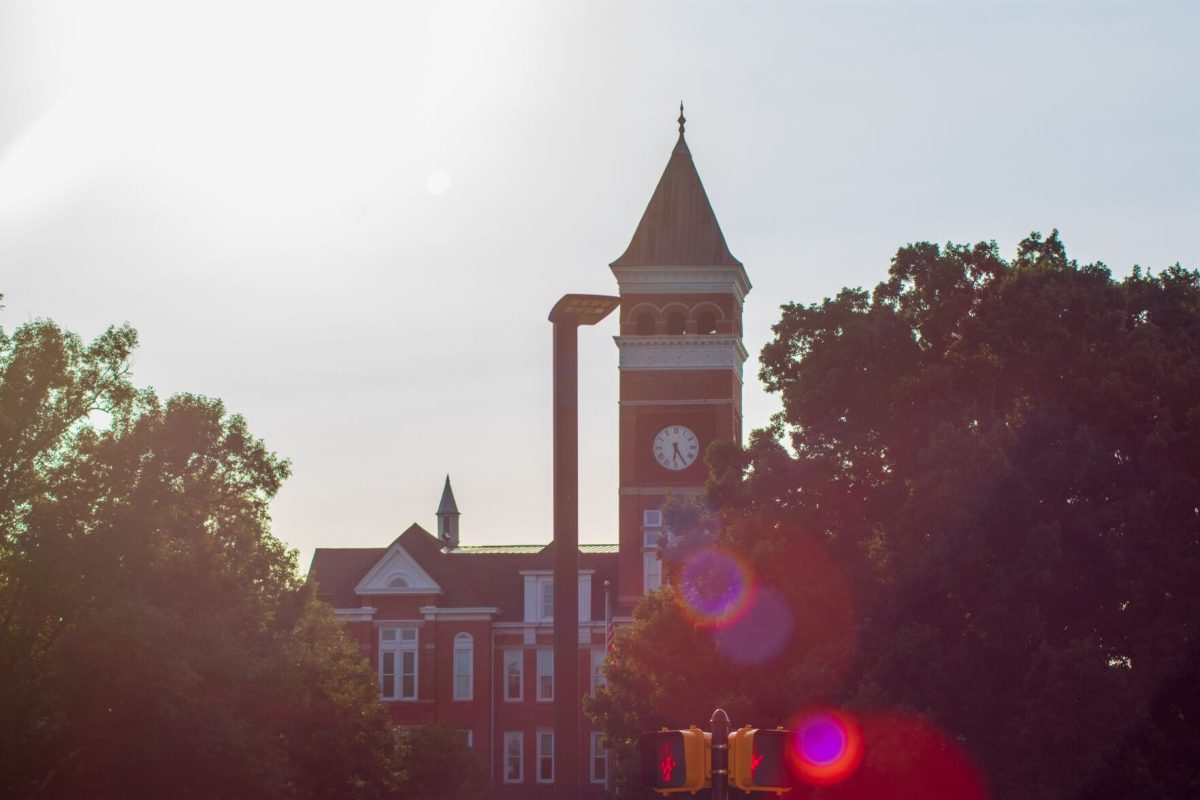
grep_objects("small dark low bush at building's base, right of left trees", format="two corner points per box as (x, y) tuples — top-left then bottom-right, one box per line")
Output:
(401, 724), (493, 800)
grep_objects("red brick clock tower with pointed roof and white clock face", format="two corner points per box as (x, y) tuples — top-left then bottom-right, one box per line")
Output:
(611, 106), (750, 614)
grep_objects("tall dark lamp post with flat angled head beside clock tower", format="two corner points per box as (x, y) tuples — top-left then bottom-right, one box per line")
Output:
(550, 294), (620, 800)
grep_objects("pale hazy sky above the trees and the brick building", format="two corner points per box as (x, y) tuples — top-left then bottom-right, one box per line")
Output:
(0, 0), (1200, 569)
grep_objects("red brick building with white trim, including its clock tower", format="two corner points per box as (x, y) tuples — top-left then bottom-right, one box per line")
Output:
(310, 114), (750, 800)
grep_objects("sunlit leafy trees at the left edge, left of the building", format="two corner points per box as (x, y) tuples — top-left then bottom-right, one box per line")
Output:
(0, 309), (402, 798)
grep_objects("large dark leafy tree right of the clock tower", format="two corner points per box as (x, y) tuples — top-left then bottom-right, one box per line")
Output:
(590, 233), (1200, 798)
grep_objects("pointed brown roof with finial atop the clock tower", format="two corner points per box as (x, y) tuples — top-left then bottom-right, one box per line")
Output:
(611, 102), (742, 266)
